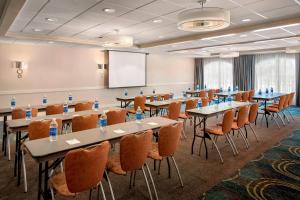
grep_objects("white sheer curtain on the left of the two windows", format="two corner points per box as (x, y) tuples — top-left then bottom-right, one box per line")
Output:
(203, 58), (233, 88)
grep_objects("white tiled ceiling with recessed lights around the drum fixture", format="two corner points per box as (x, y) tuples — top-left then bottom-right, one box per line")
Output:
(0, 0), (300, 52)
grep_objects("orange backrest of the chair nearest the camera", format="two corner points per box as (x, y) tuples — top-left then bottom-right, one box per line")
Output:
(65, 141), (109, 193)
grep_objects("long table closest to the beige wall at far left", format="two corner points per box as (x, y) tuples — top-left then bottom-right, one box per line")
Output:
(0, 101), (86, 156)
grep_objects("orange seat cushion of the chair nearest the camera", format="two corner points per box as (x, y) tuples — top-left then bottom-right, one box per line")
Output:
(49, 172), (75, 196)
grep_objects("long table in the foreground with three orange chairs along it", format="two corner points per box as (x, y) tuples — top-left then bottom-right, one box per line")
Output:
(24, 117), (178, 200)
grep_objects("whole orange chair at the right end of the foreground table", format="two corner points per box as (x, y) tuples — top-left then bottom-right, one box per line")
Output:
(148, 123), (183, 187)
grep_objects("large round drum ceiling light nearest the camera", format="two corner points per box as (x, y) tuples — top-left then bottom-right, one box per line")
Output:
(177, 0), (230, 32)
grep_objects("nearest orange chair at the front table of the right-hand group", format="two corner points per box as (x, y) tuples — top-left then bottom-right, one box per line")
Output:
(204, 110), (238, 163)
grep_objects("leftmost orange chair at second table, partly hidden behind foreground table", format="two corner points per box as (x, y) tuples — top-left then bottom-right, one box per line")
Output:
(21, 119), (62, 192)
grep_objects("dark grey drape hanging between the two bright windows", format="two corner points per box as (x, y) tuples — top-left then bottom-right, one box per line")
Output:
(233, 55), (255, 90)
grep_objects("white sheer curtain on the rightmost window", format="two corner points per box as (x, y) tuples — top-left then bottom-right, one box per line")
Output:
(255, 53), (296, 92)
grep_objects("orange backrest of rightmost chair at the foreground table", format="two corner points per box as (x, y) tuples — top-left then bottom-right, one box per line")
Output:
(158, 122), (183, 157)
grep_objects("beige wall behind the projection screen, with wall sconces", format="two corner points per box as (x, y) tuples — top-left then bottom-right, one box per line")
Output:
(0, 44), (194, 107)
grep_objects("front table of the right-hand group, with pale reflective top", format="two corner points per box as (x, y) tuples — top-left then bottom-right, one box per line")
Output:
(186, 101), (253, 159)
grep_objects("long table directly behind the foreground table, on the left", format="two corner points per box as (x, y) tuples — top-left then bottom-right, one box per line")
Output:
(6, 107), (120, 185)
